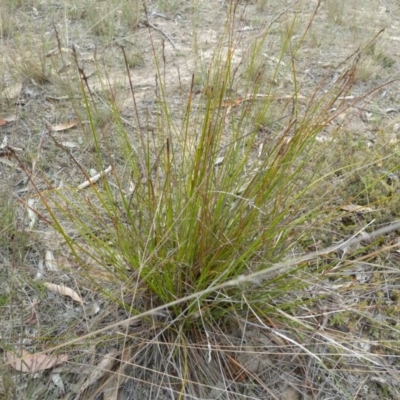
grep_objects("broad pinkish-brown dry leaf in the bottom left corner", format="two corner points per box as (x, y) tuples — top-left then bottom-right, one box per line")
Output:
(6, 350), (68, 372)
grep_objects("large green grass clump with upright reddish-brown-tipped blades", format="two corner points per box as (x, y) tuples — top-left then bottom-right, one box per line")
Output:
(46, 12), (349, 318)
